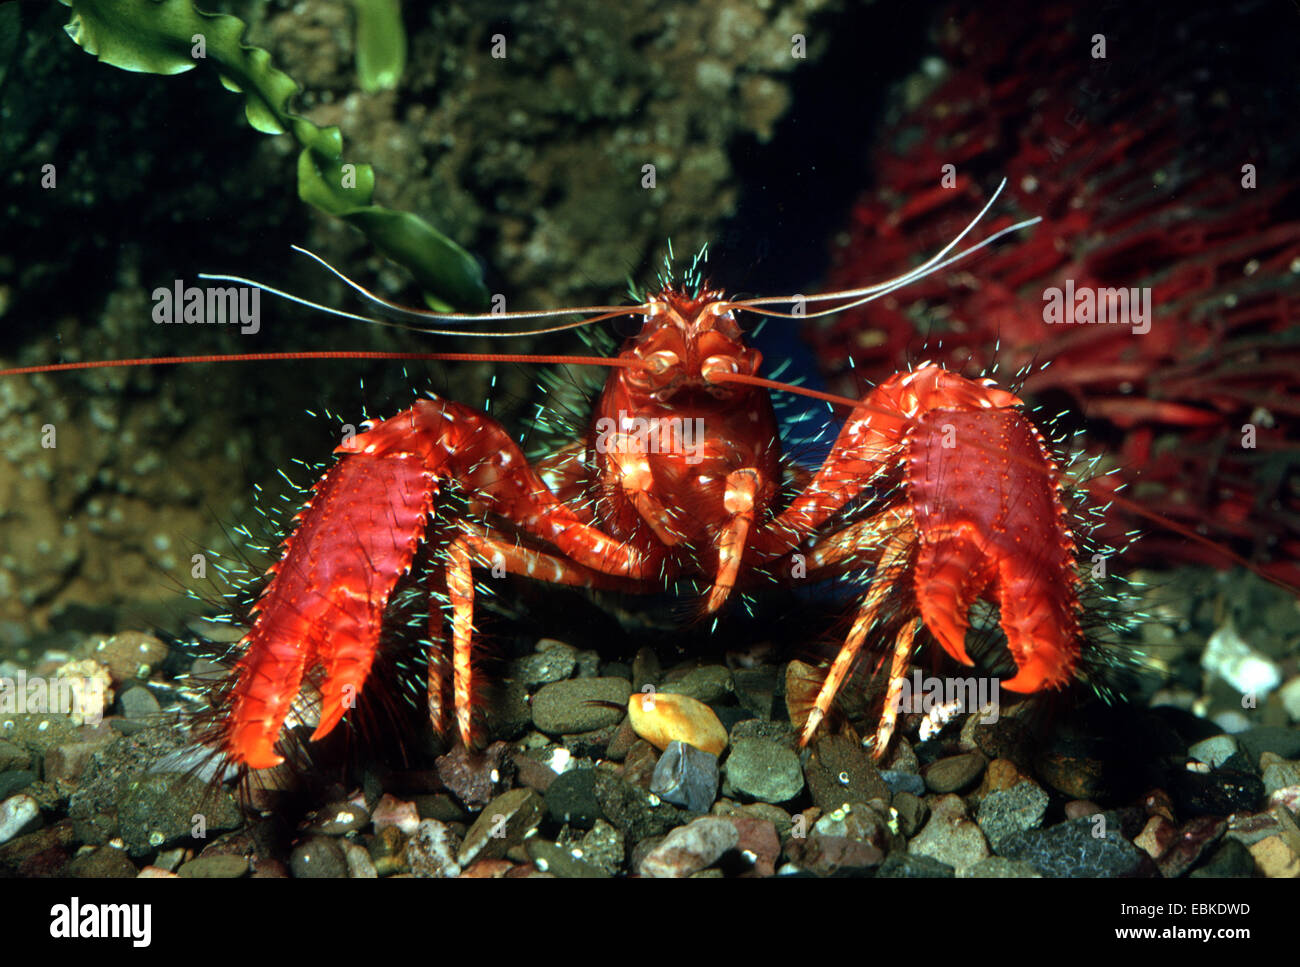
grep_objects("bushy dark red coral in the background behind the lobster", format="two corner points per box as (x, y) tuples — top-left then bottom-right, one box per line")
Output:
(811, 3), (1300, 577)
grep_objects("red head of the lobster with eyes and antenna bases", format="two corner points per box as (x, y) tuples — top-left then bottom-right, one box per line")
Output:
(623, 289), (763, 402)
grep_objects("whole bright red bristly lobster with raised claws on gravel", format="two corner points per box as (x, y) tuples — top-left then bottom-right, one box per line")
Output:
(202, 181), (1097, 768)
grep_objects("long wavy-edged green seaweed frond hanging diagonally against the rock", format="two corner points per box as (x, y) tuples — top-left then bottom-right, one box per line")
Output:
(60, 0), (488, 309)
